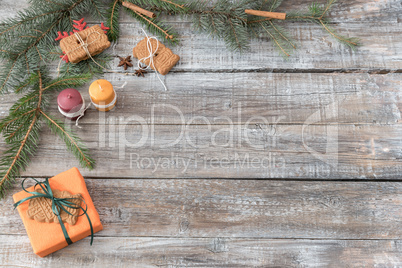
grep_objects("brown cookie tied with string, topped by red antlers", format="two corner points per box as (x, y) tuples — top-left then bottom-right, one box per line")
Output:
(60, 25), (110, 63)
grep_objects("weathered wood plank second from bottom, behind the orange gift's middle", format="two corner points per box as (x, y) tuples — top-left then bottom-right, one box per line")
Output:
(0, 178), (402, 239)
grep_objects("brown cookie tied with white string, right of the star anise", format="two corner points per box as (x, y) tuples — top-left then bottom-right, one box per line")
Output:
(133, 37), (180, 75)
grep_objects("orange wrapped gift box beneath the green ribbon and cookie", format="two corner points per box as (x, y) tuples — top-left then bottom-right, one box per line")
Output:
(13, 168), (103, 257)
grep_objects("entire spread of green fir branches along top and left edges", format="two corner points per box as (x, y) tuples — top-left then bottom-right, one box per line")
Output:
(0, 0), (359, 199)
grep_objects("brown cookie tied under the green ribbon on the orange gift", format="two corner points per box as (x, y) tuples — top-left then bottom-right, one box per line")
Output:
(27, 189), (81, 225)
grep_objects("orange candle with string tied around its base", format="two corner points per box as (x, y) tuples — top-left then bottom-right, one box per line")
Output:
(89, 79), (117, 112)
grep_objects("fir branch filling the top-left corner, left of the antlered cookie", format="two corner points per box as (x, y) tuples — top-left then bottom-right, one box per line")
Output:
(0, 0), (105, 93)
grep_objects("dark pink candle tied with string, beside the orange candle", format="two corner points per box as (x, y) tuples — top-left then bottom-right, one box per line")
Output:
(57, 88), (85, 120)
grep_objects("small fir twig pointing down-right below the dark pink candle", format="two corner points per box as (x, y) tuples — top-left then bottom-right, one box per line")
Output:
(41, 110), (95, 169)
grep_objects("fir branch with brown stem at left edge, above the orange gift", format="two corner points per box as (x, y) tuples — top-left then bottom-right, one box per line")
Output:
(0, 67), (94, 198)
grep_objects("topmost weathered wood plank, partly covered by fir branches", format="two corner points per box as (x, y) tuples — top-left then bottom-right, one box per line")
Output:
(0, 0), (402, 72)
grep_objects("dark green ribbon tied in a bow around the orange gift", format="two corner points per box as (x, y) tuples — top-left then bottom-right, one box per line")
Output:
(14, 178), (94, 246)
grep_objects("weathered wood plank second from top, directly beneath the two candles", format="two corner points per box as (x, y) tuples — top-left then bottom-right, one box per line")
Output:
(0, 73), (402, 124)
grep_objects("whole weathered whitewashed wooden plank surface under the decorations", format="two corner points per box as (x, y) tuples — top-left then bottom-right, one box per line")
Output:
(0, 0), (402, 267)
